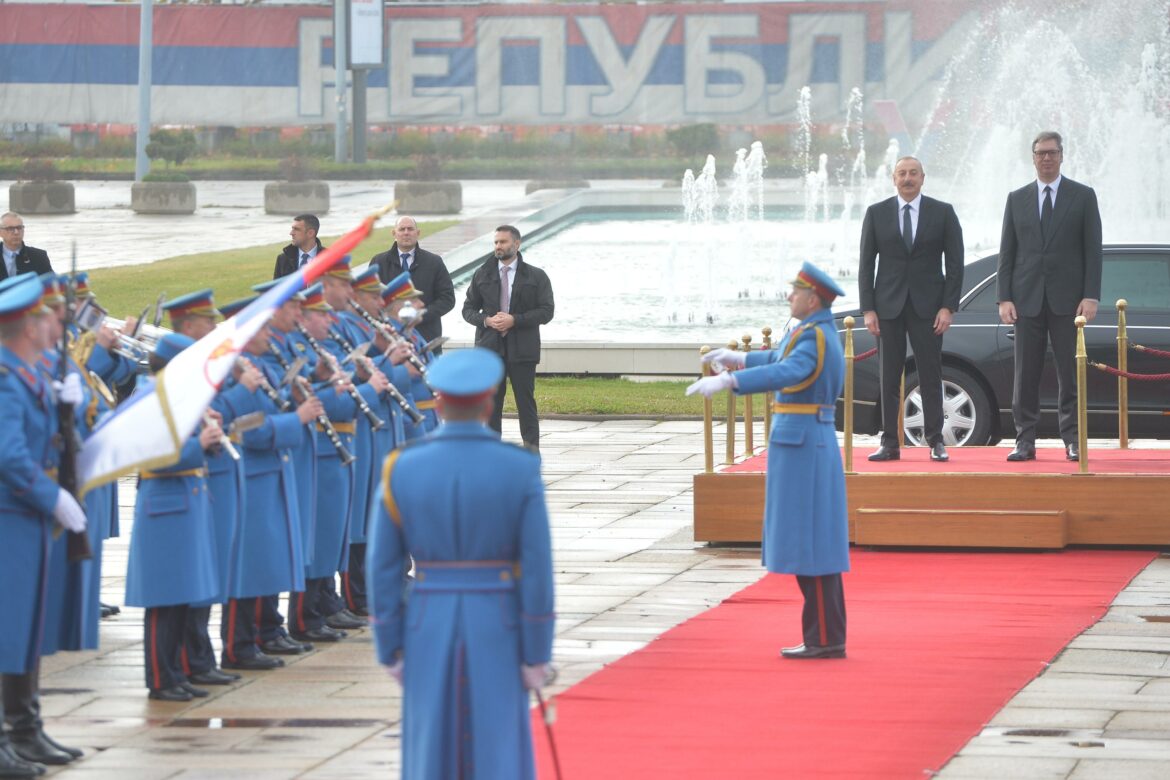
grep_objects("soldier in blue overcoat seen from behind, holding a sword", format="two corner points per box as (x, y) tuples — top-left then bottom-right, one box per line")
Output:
(366, 348), (555, 780)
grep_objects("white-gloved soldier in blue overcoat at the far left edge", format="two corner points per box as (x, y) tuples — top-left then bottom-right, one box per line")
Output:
(0, 274), (85, 778)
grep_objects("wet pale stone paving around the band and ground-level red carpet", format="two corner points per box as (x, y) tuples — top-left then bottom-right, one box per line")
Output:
(32, 420), (1170, 780)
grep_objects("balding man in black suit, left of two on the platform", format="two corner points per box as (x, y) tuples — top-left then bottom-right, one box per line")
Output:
(858, 157), (963, 461)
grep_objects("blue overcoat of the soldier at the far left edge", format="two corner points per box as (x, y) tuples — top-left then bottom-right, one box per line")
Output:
(0, 346), (60, 674)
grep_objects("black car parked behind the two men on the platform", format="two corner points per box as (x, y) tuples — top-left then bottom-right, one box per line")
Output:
(835, 244), (1170, 447)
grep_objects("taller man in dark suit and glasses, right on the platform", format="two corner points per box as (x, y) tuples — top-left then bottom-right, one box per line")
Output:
(997, 130), (1101, 461)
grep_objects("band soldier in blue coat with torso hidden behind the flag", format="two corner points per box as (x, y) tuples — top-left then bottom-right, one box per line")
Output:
(126, 333), (223, 702)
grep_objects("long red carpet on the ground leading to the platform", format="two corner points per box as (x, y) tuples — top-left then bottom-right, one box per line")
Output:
(534, 551), (1154, 780)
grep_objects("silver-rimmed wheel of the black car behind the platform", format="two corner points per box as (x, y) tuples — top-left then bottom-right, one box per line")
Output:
(903, 365), (992, 447)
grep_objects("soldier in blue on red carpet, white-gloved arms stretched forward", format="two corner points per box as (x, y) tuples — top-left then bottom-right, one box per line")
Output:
(687, 263), (849, 658)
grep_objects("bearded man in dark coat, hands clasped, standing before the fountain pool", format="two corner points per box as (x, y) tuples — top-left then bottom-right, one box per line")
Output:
(463, 225), (552, 449)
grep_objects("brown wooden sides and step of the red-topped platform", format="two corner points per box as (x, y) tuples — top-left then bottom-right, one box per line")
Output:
(694, 471), (1170, 548)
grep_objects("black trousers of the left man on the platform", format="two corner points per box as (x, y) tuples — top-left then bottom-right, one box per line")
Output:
(878, 302), (943, 447)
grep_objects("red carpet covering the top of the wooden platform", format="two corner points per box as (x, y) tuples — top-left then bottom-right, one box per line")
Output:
(720, 447), (1170, 475)
